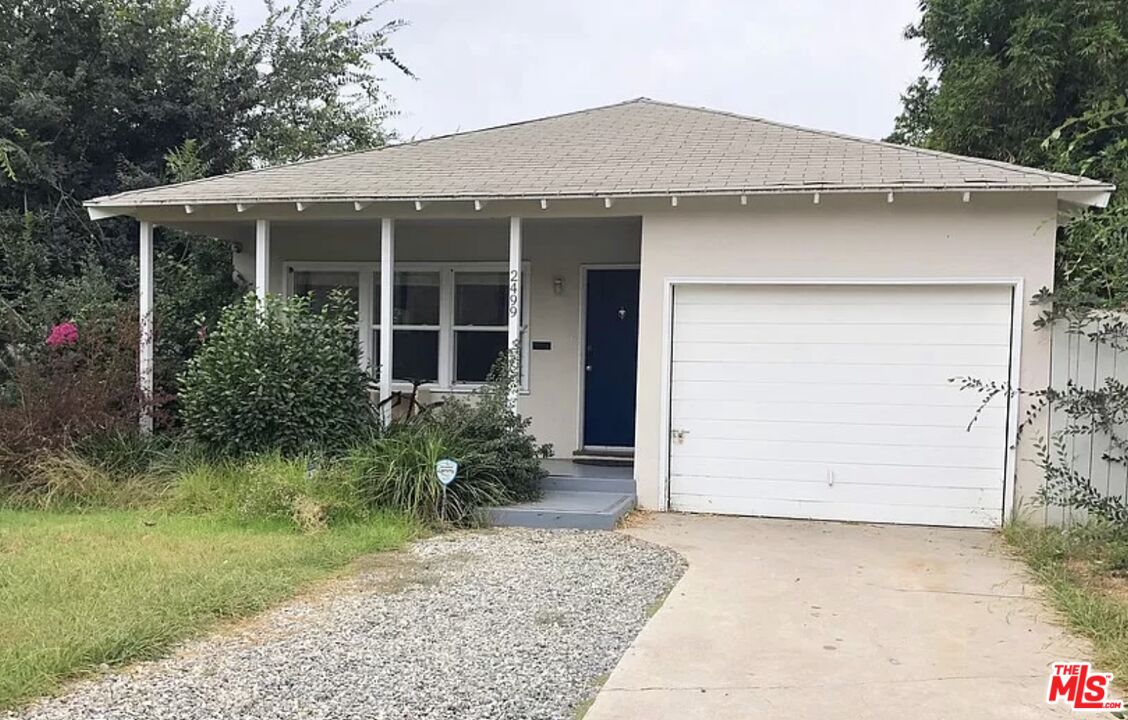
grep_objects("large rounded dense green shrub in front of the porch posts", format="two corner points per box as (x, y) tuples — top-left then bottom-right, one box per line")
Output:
(179, 293), (372, 456)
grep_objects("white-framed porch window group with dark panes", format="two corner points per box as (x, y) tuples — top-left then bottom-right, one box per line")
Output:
(291, 263), (528, 387)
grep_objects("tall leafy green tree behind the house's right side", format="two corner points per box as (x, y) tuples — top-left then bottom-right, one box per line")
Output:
(889, 0), (1128, 307)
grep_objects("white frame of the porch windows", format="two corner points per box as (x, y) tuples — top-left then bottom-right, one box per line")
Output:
(283, 261), (532, 394)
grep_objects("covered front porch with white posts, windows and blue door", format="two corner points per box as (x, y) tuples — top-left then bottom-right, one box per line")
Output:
(141, 208), (642, 457)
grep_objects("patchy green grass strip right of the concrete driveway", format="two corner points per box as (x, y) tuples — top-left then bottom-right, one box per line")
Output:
(1004, 525), (1128, 690)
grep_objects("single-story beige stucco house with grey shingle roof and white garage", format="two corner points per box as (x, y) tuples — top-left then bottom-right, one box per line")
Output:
(87, 98), (1113, 526)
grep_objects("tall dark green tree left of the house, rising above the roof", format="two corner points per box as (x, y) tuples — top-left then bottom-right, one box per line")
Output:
(0, 0), (407, 379)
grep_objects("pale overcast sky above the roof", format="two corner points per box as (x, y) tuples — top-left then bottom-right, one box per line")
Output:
(226, 0), (922, 139)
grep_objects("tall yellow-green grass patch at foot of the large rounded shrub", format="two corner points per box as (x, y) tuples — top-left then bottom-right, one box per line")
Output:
(168, 453), (369, 530)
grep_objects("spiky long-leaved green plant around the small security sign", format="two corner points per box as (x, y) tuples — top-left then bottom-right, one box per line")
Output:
(347, 422), (512, 523)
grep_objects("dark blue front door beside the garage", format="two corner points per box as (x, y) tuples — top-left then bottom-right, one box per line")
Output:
(583, 269), (638, 448)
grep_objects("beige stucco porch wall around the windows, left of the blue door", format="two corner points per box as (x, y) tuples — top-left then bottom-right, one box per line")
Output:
(235, 217), (640, 457)
